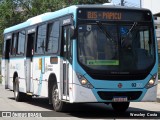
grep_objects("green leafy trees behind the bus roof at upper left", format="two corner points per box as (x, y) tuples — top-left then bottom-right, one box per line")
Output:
(0, 0), (108, 48)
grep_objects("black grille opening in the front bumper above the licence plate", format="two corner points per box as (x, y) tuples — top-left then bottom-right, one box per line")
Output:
(98, 91), (142, 100)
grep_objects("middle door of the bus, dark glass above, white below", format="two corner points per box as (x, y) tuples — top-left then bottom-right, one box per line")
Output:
(25, 33), (35, 94)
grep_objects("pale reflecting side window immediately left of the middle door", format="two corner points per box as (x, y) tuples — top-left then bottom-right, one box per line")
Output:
(17, 31), (26, 55)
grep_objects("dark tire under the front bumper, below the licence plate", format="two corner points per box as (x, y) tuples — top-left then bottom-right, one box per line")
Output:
(112, 102), (129, 112)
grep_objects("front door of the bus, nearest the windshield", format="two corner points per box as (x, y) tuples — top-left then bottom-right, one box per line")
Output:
(62, 26), (72, 101)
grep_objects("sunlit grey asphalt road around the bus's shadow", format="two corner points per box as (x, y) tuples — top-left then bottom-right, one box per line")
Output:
(0, 85), (160, 120)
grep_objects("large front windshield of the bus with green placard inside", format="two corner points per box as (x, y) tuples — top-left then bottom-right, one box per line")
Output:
(78, 23), (155, 72)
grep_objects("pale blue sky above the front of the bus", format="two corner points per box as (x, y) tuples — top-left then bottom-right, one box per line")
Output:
(112, 0), (140, 7)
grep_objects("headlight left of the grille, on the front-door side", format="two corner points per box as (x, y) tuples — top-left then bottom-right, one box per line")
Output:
(77, 73), (93, 89)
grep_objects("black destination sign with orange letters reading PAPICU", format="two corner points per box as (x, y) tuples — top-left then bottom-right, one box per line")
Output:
(78, 8), (152, 21)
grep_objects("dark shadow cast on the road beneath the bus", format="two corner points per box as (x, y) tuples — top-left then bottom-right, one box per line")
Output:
(9, 97), (159, 119)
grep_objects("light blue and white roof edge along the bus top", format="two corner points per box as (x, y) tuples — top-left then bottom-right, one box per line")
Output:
(3, 5), (147, 34)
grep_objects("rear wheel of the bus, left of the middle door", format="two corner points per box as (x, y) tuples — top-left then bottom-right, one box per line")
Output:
(13, 77), (26, 102)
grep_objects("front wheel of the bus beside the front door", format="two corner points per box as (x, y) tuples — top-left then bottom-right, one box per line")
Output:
(52, 84), (66, 112)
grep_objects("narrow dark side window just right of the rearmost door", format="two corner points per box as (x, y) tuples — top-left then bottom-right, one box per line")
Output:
(11, 33), (18, 56)
